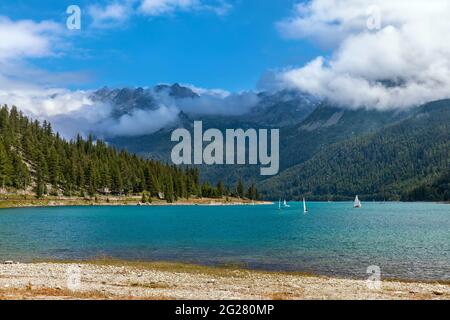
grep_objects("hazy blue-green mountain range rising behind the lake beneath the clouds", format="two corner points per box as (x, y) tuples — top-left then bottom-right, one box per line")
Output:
(92, 84), (450, 200)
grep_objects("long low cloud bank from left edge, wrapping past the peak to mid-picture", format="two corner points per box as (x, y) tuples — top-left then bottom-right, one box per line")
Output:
(0, 87), (259, 139)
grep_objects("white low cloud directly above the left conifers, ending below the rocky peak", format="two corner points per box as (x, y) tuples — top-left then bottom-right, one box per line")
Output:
(0, 89), (180, 139)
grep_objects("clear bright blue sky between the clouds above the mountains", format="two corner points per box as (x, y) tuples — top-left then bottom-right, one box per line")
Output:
(0, 0), (322, 91)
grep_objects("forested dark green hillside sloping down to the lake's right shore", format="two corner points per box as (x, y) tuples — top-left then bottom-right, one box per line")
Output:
(261, 100), (450, 200)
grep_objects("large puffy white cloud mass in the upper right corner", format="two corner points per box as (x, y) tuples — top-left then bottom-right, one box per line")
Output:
(276, 0), (450, 110)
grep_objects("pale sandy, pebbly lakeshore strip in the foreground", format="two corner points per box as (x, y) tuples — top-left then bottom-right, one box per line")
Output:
(0, 262), (450, 300)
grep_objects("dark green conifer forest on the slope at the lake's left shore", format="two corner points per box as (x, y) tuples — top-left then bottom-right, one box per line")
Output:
(0, 105), (259, 202)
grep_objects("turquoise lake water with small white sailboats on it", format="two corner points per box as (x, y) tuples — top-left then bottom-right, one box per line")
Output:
(0, 202), (450, 280)
